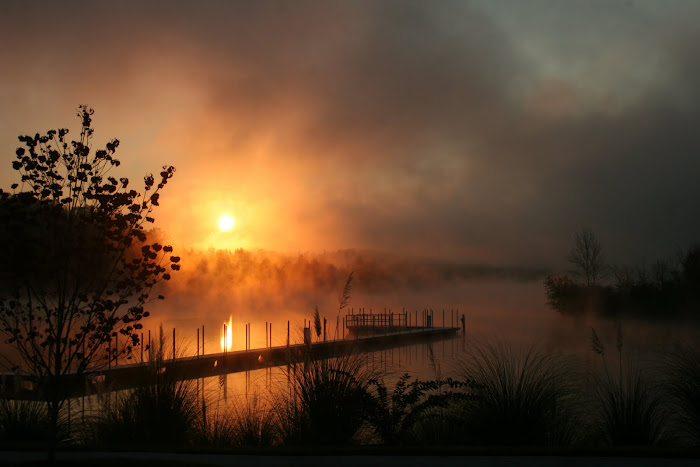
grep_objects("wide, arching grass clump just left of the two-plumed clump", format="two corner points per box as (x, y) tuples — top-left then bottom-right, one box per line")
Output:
(454, 340), (581, 446)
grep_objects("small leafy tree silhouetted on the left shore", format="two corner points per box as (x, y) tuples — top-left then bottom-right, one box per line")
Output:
(0, 106), (180, 459)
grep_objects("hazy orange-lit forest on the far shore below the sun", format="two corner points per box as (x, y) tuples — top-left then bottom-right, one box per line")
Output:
(156, 241), (546, 293)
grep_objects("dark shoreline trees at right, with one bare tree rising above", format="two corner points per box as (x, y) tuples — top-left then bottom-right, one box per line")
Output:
(544, 229), (700, 319)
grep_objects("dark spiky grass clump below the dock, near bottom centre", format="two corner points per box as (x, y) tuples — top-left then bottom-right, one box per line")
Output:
(280, 353), (377, 445)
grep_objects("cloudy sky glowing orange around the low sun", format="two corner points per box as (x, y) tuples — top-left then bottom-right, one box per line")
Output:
(0, 0), (700, 267)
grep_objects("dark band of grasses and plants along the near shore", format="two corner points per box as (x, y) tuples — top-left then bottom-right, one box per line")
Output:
(0, 331), (700, 449)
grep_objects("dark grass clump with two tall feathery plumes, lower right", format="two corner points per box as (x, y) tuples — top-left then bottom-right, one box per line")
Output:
(591, 328), (669, 446)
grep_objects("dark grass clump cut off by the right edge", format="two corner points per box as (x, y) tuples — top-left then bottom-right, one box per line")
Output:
(661, 344), (700, 446)
